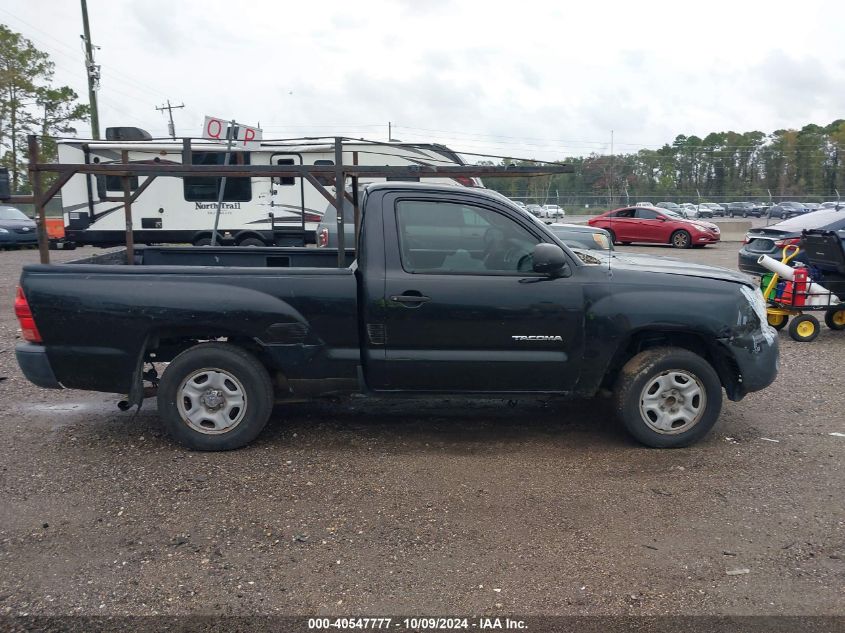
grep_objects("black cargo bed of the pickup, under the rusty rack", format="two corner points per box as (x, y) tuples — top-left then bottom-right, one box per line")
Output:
(21, 247), (360, 393)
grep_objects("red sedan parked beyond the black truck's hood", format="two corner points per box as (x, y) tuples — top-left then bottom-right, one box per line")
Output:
(588, 207), (719, 248)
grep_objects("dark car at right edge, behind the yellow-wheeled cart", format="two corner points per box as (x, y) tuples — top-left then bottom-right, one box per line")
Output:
(739, 209), (845, 275)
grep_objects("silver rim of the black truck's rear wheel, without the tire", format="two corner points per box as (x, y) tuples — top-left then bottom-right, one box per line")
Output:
(176, 368), (247, 435)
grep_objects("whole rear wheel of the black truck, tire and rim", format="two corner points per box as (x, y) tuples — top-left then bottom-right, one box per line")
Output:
(158, 343), (273, 451)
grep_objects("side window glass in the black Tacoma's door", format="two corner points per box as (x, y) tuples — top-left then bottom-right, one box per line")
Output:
(396, 200), (540, 274)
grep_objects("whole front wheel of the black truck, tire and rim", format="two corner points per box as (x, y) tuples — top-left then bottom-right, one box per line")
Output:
(614, 347), (722, 448)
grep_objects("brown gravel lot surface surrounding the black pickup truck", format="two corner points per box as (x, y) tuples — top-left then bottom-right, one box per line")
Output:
(0, 243), (845, 615)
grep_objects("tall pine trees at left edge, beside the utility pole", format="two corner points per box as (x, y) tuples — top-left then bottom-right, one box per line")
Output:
(0, 24), (88, 193)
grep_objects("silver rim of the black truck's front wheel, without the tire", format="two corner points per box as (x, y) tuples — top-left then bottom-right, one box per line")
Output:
(640, 369), (707, 435)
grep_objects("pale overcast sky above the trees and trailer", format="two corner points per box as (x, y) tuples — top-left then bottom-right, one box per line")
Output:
(0, 0), (845, 159)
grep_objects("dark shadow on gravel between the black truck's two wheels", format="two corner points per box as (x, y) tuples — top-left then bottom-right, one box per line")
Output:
(258, 397), (635, 453)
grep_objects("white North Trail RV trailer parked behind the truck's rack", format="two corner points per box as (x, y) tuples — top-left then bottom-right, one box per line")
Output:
(58, 128), (482, 246)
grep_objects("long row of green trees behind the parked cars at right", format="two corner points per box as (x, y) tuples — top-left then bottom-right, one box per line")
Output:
(484, 119), (845, 206)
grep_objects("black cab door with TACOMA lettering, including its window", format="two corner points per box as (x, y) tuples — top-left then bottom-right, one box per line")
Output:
(368, 192), (584, 392)
